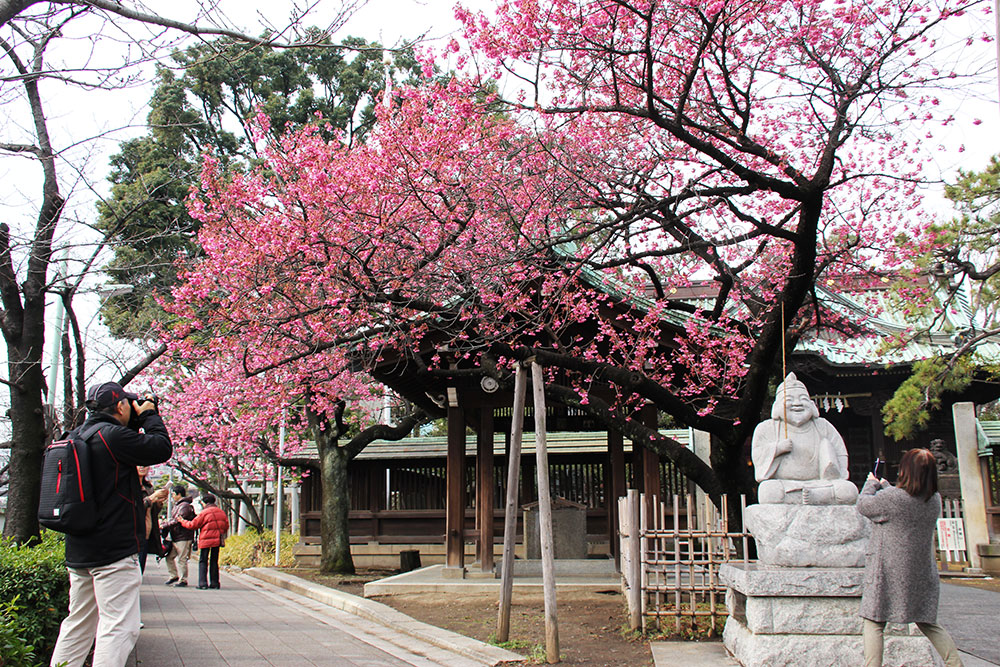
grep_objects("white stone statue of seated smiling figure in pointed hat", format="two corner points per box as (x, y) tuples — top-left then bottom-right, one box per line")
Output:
(751, 373), (858, 505)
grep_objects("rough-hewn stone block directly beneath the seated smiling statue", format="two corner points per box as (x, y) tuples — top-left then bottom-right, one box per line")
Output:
(744, 504), (871, 567)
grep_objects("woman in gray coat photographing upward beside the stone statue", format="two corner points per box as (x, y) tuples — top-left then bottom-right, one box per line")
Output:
(857, 449), (962, 667)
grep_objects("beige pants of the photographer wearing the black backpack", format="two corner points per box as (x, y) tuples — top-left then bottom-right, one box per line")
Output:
(50, 554), (142, 667)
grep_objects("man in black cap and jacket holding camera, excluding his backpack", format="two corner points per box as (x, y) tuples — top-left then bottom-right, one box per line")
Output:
(51, 382), (173, 667)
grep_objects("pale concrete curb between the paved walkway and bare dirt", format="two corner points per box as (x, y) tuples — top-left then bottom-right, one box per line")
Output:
(243, 567), (524, 665)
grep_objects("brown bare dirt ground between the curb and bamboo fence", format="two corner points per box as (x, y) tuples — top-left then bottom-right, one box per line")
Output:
(285, 569), (653, 667)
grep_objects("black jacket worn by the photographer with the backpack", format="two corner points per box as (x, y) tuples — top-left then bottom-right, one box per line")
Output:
(66, 411), (173, 567)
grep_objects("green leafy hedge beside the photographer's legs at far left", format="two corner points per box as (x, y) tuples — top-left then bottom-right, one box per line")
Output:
(0, 531), (69, 667)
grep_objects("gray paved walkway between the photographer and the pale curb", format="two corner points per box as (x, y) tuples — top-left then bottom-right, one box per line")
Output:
(133, 558), (496, 667)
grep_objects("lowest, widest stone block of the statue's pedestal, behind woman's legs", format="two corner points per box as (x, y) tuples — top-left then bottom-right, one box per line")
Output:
(722, 617), (942, 667)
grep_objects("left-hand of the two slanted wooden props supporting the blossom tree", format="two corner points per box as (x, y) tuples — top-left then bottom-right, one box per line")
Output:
(497, 364), (527, 642)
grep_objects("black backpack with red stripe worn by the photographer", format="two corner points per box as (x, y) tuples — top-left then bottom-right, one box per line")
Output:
(38, 424), (104, 535)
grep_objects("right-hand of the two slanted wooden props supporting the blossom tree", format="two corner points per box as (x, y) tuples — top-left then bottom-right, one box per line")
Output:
(531, 362), (559, 665)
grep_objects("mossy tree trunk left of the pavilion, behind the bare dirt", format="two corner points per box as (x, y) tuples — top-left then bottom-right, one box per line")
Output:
(317, 438), (354, 574)
